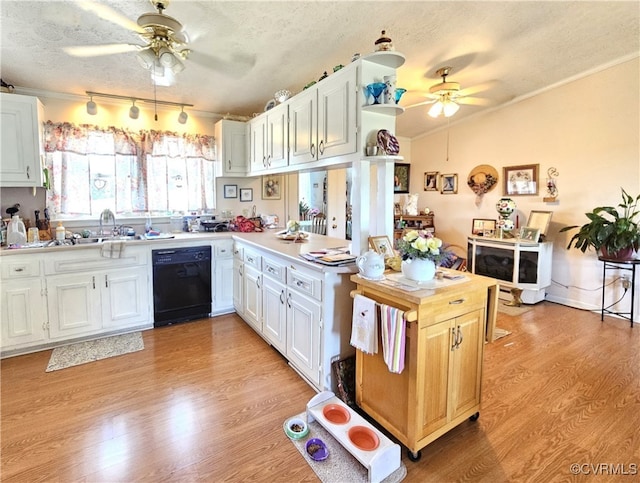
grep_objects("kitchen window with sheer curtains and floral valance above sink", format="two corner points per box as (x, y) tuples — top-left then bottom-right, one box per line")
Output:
(45, 122), (215, 217)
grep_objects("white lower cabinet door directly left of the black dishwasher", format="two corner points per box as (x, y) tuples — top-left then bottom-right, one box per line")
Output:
(102, 267), (151, 329)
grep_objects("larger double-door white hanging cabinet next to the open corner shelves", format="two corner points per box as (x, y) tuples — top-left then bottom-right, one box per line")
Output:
(289, 68), (358, 165)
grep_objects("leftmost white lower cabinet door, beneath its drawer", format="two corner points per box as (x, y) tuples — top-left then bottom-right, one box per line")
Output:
(0, 278), (47, 348)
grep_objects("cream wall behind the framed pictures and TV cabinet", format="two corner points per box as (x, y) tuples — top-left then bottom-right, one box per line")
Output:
(410, 58), (640, 318)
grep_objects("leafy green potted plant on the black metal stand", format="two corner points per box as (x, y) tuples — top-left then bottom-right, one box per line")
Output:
(560, 189), (640, 260)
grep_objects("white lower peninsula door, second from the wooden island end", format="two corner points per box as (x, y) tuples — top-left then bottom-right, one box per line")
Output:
(262, 277), (287, 354)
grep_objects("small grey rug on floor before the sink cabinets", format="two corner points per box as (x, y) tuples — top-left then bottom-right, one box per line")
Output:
(45, 332), (144, 372)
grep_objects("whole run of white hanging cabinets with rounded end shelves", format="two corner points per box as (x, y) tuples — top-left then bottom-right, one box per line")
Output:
(247, 51), (404, 174)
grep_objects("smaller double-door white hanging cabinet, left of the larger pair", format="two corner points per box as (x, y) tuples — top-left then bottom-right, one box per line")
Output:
(249, 104), (289, 172)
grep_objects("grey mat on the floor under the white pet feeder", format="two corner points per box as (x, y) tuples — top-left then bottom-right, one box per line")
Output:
(283, 412), (407, 483)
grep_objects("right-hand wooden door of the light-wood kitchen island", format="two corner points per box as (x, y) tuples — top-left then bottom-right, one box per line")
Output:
(449, 309), (484, 419)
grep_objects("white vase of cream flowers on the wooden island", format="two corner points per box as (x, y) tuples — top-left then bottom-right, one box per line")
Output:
(397, 230), (448, 282)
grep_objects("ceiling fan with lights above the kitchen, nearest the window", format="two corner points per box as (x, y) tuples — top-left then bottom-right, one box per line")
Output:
(64, 0), (250, 86)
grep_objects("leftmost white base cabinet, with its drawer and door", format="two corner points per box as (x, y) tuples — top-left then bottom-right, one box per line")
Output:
(0, 256), (47, 350)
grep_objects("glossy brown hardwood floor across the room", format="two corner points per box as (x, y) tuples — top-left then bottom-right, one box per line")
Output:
(0, 302), (640, 482)
